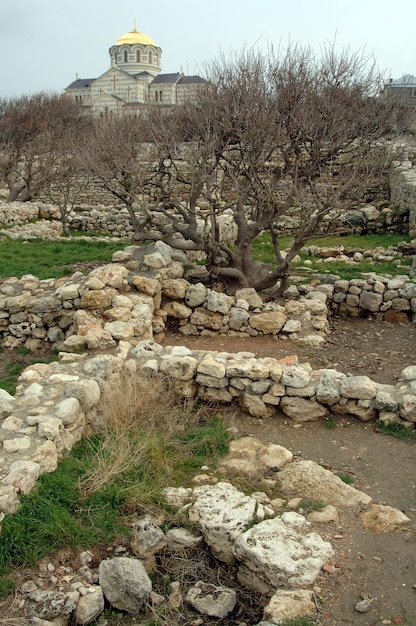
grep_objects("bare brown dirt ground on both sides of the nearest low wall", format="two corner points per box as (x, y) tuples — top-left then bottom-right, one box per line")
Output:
(163, 318), (416, 626)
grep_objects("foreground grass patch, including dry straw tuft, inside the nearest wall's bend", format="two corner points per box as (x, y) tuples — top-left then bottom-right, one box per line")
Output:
(0, 377), (230, 597)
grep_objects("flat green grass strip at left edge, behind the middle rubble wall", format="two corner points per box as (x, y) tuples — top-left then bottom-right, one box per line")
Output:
(0, 238), (123, 279)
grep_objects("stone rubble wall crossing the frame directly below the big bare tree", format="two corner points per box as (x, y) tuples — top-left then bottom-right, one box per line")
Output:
(0, 242), (416, 351)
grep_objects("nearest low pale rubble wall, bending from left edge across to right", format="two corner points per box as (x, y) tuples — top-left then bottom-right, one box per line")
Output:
(0, 332), (416, 522)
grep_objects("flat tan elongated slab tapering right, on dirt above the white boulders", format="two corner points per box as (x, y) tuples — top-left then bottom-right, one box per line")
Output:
(279, 461), (371, 507)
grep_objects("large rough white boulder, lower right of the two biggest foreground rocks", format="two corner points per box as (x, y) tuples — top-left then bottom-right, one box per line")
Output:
(233, 512), (334, 593)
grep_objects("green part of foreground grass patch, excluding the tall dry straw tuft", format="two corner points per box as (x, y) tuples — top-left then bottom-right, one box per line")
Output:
(0, 418), (230, 597)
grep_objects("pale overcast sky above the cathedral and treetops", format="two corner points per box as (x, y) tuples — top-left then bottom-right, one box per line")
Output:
(0, 0), (416, 98)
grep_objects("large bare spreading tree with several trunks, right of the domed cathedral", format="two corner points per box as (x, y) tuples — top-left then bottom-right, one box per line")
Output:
(80, 46), (404, 297)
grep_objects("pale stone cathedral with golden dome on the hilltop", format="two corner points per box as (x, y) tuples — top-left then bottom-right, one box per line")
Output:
(65, 21), (204, 115)
